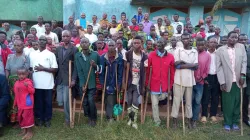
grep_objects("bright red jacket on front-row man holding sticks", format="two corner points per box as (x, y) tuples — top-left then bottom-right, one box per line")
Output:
(146, 50), (175, 92)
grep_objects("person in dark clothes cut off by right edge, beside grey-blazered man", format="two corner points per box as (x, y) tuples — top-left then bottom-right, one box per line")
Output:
(239, 34), (250, 127)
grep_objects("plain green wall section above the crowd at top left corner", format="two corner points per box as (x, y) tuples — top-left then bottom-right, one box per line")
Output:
(0, 0), (63, 21)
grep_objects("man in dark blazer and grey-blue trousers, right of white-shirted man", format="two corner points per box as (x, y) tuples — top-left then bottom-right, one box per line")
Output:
(56, 30), (78, 125)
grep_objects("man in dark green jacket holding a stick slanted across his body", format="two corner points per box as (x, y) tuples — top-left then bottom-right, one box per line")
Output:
(75, 37), (100, 127)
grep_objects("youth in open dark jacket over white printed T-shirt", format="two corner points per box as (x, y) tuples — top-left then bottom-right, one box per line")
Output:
(125, 36), (148, 129)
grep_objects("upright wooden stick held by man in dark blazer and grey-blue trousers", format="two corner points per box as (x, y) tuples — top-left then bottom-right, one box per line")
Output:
(69, 60), (73, 128)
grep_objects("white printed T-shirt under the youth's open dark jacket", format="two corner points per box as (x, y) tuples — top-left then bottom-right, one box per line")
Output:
(132, 51), (142, 85)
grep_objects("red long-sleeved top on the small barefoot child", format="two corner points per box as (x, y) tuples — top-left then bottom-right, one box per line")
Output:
(14, 78), (35, 109)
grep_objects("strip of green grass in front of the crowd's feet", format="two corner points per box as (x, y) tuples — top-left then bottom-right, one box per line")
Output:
(0, 112), (250, 140)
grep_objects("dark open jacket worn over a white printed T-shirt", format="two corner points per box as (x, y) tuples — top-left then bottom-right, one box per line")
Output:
(125, 50), (148, 95)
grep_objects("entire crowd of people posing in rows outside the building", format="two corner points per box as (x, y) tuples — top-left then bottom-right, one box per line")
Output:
(0, 7), (250, 139)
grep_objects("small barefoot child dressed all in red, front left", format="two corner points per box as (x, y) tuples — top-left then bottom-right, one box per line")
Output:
(13, 67), (35, 139)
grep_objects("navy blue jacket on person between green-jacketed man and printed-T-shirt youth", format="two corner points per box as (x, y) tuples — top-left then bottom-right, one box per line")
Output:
(99, 52), (123, 94)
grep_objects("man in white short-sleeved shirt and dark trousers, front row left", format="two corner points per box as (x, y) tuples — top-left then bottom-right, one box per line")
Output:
(30, 36), (58, 127)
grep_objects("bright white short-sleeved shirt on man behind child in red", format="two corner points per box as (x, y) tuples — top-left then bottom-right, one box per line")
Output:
(29, 49), (58, 89)
